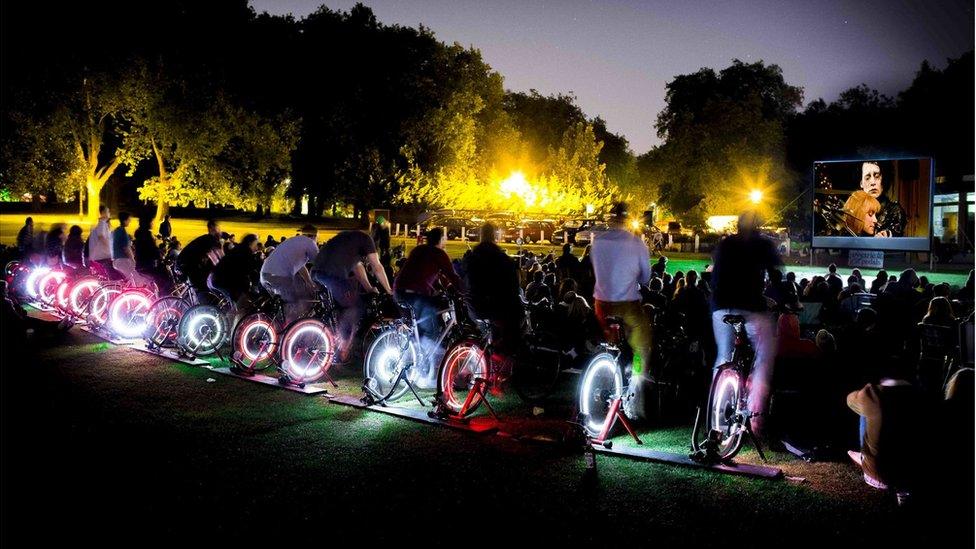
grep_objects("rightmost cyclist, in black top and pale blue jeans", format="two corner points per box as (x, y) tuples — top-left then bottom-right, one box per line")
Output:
(712, 212), (782, 436)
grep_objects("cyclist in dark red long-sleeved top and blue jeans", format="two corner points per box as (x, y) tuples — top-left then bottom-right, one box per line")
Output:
(394, 227), (461, 388)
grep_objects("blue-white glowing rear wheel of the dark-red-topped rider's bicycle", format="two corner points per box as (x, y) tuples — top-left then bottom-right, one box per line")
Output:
(363, 326), (419, 401)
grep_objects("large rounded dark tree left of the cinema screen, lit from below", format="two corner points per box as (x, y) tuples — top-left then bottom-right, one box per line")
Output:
(644, 60), (803, 227)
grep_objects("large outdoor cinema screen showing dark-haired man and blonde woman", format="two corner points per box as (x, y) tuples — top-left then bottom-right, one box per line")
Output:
(813, 158), (934, 251)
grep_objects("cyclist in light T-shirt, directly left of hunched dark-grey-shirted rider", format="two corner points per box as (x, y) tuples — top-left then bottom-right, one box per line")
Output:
(261, 225), (319, 324)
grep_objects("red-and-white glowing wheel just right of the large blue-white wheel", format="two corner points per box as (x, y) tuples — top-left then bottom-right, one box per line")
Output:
(437, 339), (488, 415)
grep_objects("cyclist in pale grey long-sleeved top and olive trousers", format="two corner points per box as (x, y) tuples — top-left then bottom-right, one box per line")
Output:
(590, 203), (653, 419)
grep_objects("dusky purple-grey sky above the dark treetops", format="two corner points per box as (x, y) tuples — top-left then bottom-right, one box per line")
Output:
(252, 0), (974, 153)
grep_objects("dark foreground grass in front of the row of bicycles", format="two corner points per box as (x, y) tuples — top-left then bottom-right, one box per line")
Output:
(3, 328), (972, 546)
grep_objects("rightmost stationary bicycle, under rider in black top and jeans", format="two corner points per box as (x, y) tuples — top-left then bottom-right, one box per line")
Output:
(691, 314), (766, 463)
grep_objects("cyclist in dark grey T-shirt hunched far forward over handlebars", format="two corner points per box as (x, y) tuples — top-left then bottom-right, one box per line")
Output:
(310, 231), (393, 360)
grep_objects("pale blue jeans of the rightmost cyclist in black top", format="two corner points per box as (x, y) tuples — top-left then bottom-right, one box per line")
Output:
(712, 309), (776, 421)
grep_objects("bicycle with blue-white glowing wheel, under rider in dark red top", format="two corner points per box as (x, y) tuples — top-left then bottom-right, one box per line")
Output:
(363, 296), (458, 406)
